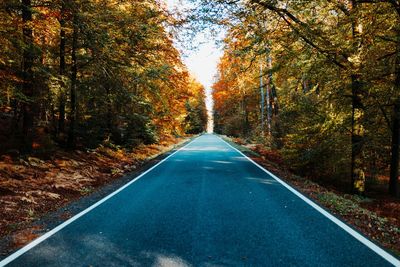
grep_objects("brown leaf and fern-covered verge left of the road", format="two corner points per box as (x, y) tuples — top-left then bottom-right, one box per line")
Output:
(0, 137), (189, 252)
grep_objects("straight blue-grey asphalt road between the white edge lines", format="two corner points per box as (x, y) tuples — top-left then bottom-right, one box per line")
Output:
(0, 135), (398, 266)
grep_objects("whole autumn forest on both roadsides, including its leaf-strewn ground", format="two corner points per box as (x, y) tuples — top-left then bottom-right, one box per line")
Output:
(0, 0), (400, 257)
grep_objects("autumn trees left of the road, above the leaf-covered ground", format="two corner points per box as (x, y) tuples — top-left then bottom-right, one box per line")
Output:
(0, 0), (207, 152)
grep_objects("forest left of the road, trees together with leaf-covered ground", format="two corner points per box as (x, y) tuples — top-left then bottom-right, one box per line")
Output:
(0, 0), (207, 241)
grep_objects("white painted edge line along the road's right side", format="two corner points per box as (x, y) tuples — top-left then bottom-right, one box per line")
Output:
(218, 136), (400, 266)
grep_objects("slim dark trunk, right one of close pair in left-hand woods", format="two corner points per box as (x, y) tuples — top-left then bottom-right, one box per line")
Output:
(67, 13), (78, 148)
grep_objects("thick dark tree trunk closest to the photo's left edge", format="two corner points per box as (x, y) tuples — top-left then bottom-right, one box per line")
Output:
(22, 0), (35, 152)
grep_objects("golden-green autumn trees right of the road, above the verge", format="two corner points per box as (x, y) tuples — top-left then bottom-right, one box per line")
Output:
(192, 0), (400, 195)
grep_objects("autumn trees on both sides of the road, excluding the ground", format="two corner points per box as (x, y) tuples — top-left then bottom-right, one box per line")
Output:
(0, 0), (400, 199)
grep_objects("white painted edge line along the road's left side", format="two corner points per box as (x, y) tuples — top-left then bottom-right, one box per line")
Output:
(0, 137), (198, 267)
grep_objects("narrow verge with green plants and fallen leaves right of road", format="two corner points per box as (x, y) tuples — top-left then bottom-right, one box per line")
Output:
(221, 136), (400, 256)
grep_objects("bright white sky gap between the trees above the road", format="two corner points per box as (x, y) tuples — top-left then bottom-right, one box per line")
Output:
(166, 0), (222, 131)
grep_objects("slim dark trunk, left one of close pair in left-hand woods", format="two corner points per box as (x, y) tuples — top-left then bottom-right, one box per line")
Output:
(58, 0), (66, 136)
